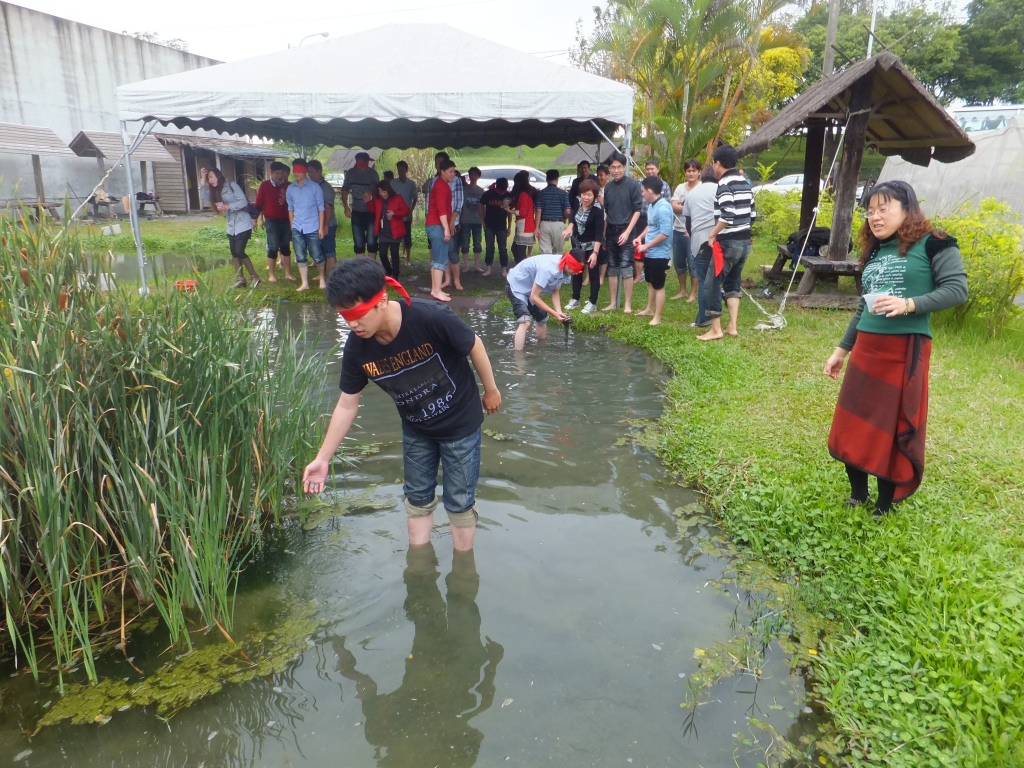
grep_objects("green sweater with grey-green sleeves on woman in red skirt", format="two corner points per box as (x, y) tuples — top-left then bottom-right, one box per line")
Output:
(839, 234), (967, 351)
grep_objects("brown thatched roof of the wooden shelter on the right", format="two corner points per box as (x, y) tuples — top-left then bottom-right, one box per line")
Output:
(736, 51), (974, 166)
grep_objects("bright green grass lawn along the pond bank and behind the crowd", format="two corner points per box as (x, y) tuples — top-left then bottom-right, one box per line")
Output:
(81, 217), (1024, 768)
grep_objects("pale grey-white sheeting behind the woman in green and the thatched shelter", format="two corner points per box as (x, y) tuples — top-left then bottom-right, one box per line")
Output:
(879, 117), (1024, 216)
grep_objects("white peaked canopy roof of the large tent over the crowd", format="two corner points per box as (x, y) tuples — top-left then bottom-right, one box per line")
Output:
(117, 24), (633, 148)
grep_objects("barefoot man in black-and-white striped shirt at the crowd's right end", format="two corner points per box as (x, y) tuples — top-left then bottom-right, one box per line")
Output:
(697, 144), (757, 341)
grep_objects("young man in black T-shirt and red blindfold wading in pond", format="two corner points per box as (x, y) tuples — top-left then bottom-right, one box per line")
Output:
(302, 259), (502, 552)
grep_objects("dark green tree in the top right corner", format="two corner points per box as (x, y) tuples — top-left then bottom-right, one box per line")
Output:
(949, 0), (1024, 103)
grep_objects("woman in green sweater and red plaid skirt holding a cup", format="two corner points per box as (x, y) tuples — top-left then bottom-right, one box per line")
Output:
(824, 181), (967, 516)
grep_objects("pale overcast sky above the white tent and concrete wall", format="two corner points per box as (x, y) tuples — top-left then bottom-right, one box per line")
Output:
(13, 0), (603, 67)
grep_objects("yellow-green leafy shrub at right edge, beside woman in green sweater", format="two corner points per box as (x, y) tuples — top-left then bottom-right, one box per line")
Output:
(932, 198), (1024, 336)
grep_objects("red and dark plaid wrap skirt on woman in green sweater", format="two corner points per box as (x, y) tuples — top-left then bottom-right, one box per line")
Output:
(828, 331), (932, 501)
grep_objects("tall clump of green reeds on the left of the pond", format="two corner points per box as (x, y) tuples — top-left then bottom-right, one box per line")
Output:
(0, 214), (323, 679)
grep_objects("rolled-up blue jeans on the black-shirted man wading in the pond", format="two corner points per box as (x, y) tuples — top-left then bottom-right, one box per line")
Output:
(401, 426), (481, 513)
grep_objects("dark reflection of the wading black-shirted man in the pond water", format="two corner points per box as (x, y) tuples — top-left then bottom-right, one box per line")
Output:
(331, 544), (505, 768)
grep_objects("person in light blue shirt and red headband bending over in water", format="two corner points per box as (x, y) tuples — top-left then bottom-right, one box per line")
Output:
(505, 248), (584, 349)
